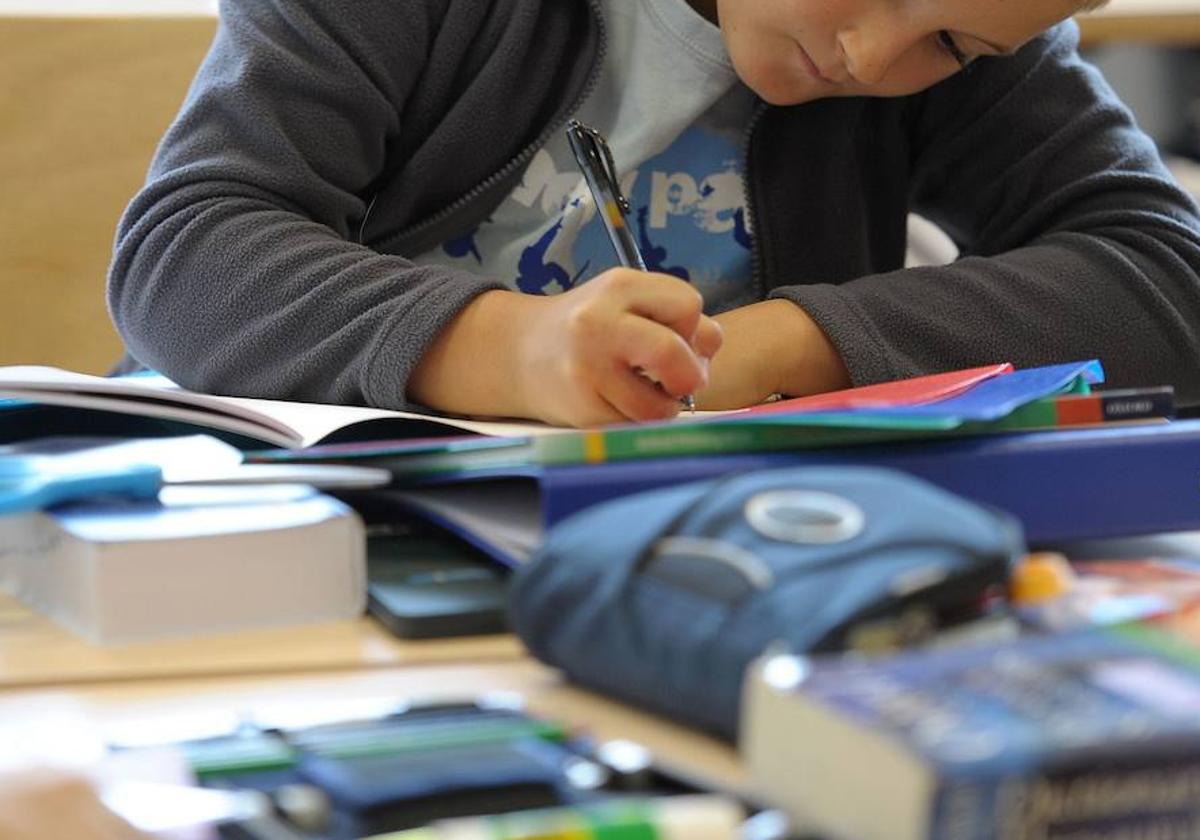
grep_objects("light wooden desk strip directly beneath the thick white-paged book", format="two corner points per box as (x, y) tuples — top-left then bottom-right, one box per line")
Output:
(0, 594), (524, 689)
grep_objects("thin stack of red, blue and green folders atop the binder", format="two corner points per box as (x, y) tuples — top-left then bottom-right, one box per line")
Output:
(251, 362), (1174, 480)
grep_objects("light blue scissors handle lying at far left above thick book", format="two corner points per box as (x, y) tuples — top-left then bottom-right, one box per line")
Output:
(0, 457), (162, 515)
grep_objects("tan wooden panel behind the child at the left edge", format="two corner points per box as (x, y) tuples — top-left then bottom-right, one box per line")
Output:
(0, 12), (216, 373)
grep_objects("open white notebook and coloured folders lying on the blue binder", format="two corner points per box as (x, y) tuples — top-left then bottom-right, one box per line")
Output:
(0, 361), (1174, 458)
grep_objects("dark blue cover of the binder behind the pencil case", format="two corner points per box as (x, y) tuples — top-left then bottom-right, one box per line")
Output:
(538, 420), (1200, 542)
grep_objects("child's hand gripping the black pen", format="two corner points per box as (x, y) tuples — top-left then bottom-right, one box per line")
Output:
(514, 269), (721, 426)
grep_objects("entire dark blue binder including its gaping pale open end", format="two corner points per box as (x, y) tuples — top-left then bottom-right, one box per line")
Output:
(380, 420), (1200, 565)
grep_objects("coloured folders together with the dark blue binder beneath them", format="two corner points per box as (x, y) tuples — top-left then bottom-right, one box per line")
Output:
(243, 362), (1200, 564)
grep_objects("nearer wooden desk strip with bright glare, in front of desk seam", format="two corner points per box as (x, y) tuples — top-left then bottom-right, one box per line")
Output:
(0, 660), (745, 790)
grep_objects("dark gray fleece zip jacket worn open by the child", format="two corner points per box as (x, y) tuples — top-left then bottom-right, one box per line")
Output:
(108, 0), (1200, 408)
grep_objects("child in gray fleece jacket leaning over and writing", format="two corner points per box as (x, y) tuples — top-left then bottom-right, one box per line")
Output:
(109, 0), (1200, 426)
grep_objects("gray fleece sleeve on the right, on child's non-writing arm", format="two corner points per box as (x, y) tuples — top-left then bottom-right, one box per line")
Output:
(774, 23), (1200, 403)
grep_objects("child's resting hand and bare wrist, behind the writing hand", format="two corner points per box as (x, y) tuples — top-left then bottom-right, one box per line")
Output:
(696, 300), (851, 410)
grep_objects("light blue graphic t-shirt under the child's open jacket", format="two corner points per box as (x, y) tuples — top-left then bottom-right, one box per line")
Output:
(416, 0), (755, 313)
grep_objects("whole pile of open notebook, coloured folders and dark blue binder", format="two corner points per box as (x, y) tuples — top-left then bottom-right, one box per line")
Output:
(0, 361), (1180, 563)
